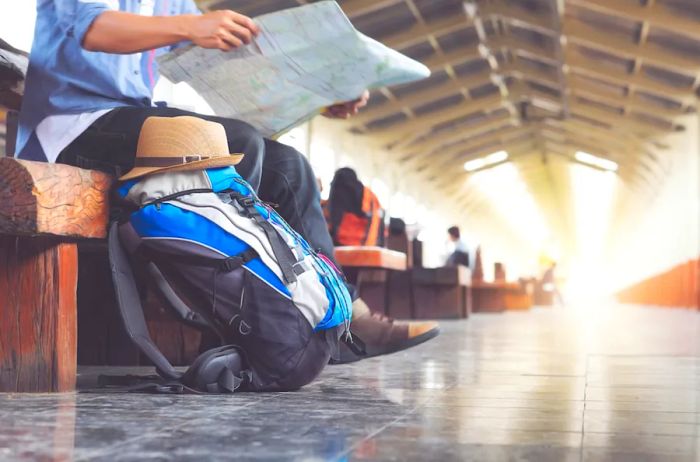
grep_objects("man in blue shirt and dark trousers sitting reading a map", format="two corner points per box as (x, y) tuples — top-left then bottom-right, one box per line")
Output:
(16, 0), (438, 364)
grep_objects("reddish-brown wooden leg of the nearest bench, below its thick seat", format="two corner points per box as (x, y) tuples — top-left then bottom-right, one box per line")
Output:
(0, 236), (78, 392)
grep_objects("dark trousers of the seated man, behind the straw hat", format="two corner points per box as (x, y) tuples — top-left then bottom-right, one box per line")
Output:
(58, 107), (333, 258)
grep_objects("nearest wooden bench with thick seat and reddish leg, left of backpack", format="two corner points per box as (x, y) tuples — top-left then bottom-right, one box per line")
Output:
(0, 158), (113, 392)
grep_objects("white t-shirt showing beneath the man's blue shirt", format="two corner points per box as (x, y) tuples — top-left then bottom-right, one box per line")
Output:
(36, 0), (155, 163)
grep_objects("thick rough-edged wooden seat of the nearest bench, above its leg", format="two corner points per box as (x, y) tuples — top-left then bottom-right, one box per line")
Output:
(0, 158), (113, 238)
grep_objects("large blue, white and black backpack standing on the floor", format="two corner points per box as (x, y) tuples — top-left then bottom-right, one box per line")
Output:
(109, 167), (352, 392)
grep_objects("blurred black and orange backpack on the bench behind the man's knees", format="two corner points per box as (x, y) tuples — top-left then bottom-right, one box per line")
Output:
(327, 167), (384, 246)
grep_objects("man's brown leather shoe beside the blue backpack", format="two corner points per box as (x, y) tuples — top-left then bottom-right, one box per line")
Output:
(331, 299), (440, 364)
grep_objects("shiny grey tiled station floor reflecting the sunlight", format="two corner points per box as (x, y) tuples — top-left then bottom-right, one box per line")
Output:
(0, 306), (700, 462)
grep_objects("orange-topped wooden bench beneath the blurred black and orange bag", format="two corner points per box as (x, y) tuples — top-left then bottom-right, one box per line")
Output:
(335, 246), (409, 316)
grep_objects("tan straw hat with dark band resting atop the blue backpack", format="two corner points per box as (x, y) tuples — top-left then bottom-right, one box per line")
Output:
(119, 116), (243, 181)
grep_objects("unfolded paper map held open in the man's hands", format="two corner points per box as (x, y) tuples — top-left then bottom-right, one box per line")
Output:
(159, 1), (430, 136)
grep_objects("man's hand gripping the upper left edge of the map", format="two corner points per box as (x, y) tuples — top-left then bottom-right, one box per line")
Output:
(188, 10), (260, 51)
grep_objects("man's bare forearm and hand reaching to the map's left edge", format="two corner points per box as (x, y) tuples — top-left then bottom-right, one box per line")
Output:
(82, 10), (260, 54)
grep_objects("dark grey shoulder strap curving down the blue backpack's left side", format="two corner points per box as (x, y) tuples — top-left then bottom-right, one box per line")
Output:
(107, 222), (182, 380)
